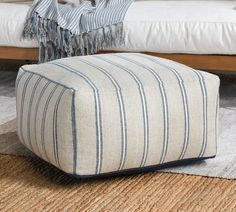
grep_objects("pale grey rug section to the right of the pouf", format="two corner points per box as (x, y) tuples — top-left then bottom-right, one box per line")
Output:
(164, 108), (236, 179)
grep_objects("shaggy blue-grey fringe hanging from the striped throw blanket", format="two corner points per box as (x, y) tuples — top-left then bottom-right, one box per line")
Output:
(23, 12), (124, 63)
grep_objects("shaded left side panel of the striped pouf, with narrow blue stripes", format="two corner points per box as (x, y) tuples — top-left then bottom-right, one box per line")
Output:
(16, 68), (75, 173)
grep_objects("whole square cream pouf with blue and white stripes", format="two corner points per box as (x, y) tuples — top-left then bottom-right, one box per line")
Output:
(16, 53), (219, 177)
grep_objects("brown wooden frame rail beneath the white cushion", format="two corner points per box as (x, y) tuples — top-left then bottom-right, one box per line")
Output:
(0, 47), (236, 73)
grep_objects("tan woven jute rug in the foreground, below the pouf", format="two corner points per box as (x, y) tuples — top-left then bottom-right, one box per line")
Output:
(0, 155), (236, 212)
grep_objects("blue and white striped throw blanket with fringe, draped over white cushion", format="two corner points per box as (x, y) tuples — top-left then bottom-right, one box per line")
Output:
(23, 0), (133, 63)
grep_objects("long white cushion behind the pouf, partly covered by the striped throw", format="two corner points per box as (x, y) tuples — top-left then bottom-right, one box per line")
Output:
(0, 1), (236, 54)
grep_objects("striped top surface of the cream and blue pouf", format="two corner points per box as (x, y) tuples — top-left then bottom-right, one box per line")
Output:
(21, 53), (218, 90)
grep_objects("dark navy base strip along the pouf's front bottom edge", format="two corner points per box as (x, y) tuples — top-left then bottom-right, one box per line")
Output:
(68, 155), (216, 179)
